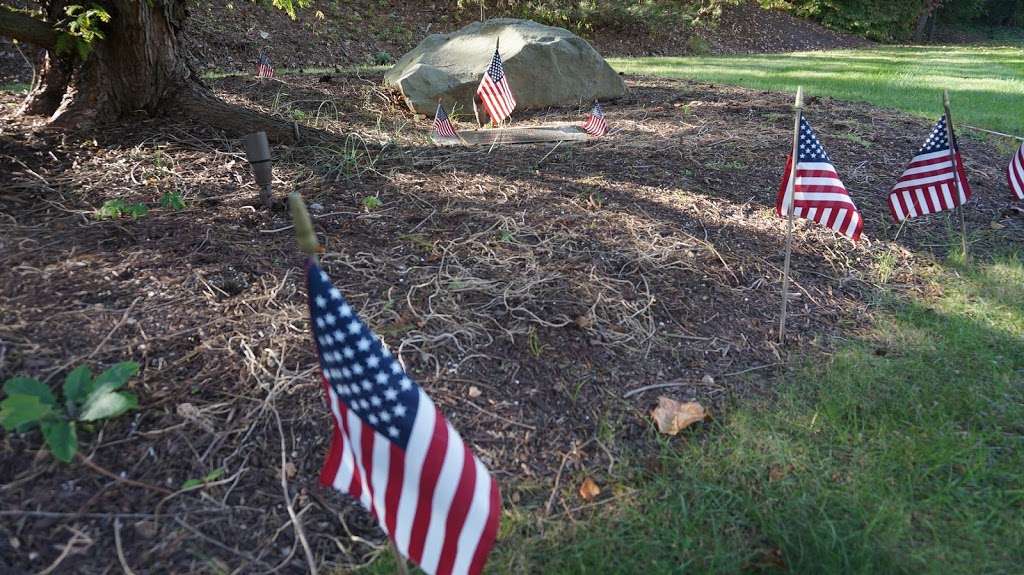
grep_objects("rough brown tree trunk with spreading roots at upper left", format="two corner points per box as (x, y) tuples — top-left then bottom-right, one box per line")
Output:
(0, 0), (323, 143)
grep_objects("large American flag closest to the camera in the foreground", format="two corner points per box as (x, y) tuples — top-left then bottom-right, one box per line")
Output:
(306, 261), (501, 574)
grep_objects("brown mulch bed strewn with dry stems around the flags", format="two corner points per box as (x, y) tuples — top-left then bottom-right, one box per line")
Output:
(0, 77), (1024, 573)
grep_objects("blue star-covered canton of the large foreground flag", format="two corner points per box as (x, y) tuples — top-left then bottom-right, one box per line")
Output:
(306, 264), (420, 449)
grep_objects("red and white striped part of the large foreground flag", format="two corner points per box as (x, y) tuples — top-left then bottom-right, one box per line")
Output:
(321, 382), (501, 575)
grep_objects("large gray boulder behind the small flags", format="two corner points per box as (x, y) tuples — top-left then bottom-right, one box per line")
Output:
(384, 18), (626, 115)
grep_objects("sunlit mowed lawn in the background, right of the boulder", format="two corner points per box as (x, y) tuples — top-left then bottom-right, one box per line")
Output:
(609, 46), (1024, 135)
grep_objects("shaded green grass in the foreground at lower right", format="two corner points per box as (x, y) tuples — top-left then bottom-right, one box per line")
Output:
(490, 256), (1024, 574)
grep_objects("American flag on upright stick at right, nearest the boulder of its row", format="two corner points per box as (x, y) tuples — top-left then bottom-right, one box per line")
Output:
(775, 114), (864, 241)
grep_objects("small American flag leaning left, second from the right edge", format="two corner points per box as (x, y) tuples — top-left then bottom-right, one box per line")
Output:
(889, 116), (971, 222)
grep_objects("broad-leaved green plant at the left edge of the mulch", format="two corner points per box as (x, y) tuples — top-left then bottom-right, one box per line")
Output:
(0, 361), (138, 462)
